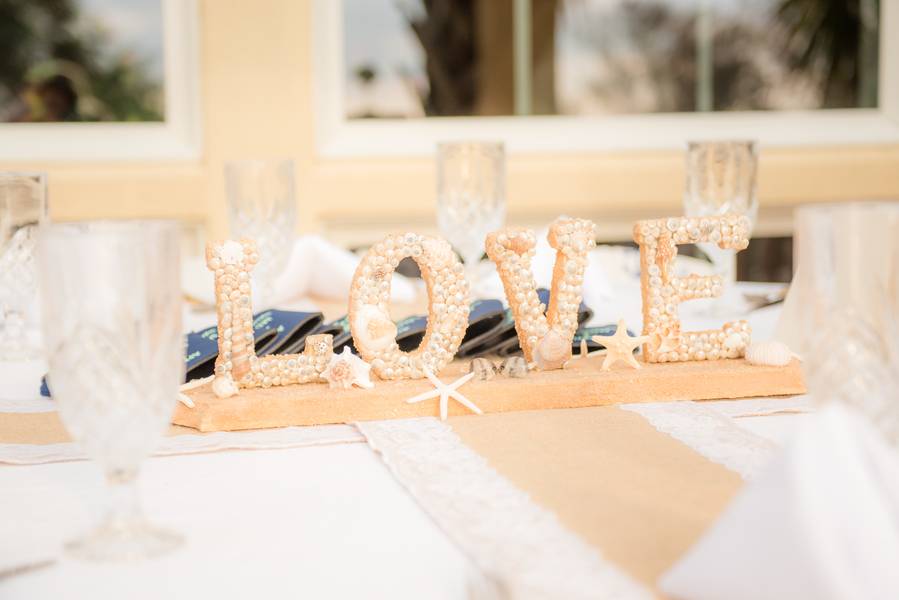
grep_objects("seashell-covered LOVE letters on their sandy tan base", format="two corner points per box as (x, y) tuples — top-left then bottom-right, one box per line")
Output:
(174, 215), (805, 431)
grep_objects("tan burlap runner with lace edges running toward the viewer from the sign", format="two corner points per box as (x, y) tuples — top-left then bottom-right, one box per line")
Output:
(357, 400), (807, 598)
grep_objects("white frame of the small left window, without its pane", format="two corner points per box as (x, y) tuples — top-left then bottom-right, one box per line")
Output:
(0, 0), (202, 161)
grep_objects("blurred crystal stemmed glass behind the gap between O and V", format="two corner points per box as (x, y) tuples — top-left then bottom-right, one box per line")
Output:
(437, 142), (506, 293)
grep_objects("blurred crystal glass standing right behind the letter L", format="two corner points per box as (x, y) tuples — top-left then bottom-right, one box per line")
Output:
(225, 160), (296, 302)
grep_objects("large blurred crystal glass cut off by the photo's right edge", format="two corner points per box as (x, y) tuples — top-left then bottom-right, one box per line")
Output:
(777, 201), (899, 446)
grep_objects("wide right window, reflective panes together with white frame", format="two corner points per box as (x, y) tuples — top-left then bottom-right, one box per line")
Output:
(313, 0), (899, 157)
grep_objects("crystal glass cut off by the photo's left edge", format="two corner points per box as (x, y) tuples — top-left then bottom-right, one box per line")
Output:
(0, 172), (47, 360)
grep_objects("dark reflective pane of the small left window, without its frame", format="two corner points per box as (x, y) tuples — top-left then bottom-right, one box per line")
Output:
(0, 0), (165, 123)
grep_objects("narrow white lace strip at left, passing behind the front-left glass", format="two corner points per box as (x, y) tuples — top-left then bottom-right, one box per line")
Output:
(0, 425), (365, 465)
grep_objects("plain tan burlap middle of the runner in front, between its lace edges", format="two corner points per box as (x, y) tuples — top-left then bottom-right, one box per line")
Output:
(450, 406), (742, 589)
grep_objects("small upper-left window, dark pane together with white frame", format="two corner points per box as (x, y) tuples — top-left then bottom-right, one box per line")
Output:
(0, 0), (201, 161)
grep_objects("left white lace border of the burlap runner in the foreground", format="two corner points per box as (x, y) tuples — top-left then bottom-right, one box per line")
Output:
(356, 418), (652, 600)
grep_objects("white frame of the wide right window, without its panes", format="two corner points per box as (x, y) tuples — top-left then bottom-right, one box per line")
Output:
(312, 0), (899, 158)
